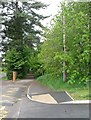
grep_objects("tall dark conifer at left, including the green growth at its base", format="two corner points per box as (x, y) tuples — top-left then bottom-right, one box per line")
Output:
(0, 0), (46, 79)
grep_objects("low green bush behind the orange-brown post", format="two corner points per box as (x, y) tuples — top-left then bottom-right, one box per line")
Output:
(5, 48), (30, 79)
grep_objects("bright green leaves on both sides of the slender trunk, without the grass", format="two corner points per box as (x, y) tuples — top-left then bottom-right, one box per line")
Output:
(39, 2), (91, 84)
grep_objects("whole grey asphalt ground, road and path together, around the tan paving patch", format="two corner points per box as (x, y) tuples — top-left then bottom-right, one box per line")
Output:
(2, 79), (90, 118)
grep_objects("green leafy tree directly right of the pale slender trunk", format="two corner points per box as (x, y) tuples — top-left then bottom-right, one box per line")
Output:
(65, 2), (89, 83)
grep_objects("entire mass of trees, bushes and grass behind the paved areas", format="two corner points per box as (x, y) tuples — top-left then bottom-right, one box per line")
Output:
(0, 1), (91, 99)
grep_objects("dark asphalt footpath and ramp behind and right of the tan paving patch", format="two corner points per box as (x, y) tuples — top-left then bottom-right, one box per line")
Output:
(27, 81), (73, 103)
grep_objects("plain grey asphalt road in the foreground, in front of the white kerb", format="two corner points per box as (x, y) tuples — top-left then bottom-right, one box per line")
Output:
(19, 98), (89, 118)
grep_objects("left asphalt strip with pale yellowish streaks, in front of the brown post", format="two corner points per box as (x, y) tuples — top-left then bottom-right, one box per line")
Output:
(0, 80), (30, 119)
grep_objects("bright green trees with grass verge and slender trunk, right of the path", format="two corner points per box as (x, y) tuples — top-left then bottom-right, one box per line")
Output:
(37, 2), (91, 99)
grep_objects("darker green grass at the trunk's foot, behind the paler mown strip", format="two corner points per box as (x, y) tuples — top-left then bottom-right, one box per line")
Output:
(37, 73), (86, 90)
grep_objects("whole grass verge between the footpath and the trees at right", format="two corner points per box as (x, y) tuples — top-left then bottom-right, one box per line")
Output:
(37, 74), (91, 100)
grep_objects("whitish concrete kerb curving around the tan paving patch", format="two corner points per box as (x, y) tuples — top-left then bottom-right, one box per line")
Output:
(27, 84), (91, 104)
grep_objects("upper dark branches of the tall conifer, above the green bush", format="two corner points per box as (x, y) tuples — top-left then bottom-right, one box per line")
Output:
(1, 0), (46, 51)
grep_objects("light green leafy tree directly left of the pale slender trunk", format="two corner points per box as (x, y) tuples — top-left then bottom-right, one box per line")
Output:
(38, 16), (63, 75)
